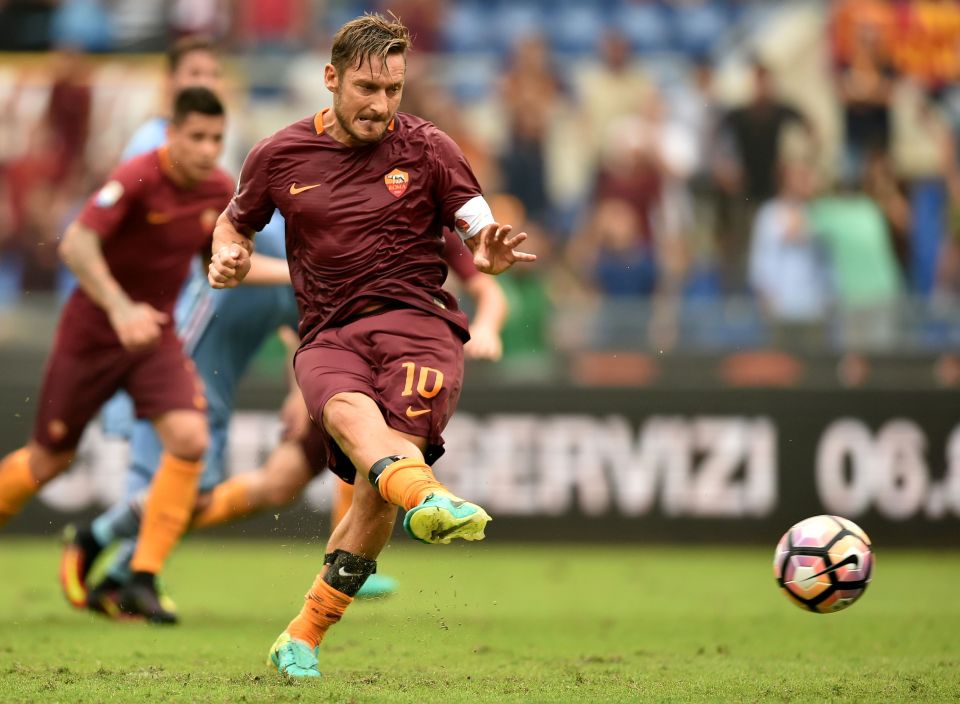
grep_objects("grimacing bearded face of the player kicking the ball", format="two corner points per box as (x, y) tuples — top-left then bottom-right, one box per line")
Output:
(324, 53), (407, 147)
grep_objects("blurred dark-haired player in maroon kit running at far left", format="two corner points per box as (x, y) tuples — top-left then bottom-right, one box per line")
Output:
(0, 88), (233, 621)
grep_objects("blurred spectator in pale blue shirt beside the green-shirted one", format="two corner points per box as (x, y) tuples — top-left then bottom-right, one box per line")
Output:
(749, 160), (831, 353)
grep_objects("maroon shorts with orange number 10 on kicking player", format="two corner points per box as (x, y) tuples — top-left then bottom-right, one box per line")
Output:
(293, 308), (463, 483)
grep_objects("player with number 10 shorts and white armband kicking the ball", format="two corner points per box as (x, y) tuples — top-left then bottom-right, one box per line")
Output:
(208, 14), (536, 677)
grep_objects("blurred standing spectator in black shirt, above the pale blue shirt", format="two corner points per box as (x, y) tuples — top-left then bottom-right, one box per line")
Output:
(714, 61), (815, 292)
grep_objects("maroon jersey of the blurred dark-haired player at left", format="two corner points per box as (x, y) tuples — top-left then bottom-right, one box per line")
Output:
(70, 147), (233, 342)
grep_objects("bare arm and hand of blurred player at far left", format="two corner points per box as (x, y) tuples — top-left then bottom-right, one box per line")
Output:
(57, 222), (169, 350)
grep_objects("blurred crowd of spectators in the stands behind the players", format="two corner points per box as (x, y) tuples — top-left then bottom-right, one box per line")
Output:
(0, 0), (960, 359)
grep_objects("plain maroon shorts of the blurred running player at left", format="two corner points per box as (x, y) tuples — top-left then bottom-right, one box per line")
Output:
(33, 327), (207, 452)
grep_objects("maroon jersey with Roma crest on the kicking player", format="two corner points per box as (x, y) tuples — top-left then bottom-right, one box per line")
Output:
(226, 113), (480, 344)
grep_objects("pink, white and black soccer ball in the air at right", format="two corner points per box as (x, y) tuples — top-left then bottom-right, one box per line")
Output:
(773, 516), (873, 614)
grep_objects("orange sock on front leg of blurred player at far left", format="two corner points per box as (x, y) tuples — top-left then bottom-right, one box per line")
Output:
(130, 452), (203, 574)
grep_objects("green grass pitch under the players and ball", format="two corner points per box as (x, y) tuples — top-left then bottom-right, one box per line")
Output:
(0, 538), (960, 704)
